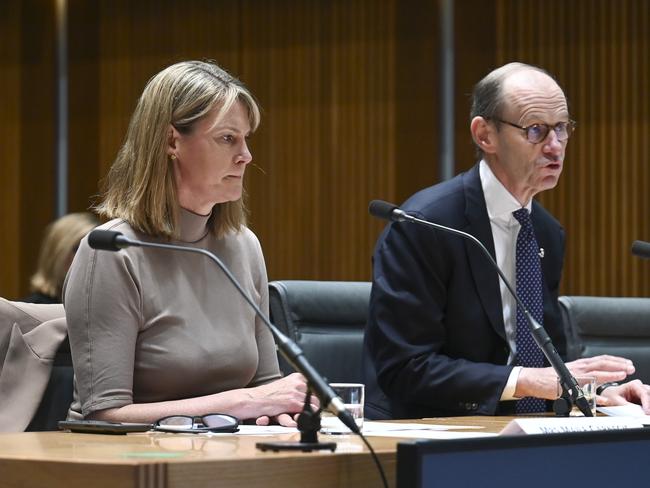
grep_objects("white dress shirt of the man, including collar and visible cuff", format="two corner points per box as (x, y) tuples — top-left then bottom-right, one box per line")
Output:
(479, 160), (532, 400)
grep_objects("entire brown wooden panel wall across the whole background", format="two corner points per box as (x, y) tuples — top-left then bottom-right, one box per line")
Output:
(0, 0), (650, 298)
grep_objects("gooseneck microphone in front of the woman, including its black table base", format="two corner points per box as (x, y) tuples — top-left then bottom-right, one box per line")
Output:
(88, 230), (354, 451)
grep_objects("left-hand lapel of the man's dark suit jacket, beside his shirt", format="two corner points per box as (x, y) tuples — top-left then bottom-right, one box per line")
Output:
(463, 164), (506, 340)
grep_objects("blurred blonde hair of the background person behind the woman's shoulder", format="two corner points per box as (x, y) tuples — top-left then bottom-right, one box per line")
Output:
(30, 212), (99, 299)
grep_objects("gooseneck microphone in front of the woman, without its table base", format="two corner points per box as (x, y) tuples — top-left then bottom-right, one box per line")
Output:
(88, 229), (361, 434)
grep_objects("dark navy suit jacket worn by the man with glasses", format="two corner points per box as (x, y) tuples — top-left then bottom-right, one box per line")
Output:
(364, 165), (566, 418)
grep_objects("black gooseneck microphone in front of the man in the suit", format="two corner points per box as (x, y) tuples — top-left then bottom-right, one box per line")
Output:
(368, 200), (593, 417)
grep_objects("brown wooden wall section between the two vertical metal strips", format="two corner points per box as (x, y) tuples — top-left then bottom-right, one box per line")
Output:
(64, 0), (437, 280)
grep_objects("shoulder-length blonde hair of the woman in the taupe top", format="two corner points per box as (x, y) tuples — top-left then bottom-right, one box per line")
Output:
(95, 61), (260, 238)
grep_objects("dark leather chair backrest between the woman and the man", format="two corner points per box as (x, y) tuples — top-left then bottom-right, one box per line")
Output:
(269, 280), (371, 383)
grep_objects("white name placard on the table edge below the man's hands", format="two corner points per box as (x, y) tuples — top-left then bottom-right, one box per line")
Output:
(500, 417), (643, 435)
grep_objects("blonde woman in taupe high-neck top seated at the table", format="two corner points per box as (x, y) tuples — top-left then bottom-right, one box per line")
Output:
(64, 61), (306, 425)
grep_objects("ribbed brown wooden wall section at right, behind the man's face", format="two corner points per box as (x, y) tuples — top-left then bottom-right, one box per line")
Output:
(496, 0), (650, 296)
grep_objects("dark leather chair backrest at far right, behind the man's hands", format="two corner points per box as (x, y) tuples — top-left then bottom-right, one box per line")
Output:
(560, 296), (650, 383)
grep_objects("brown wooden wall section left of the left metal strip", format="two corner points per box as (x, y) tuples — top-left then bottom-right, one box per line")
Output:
(0, 0), (55, 298)
